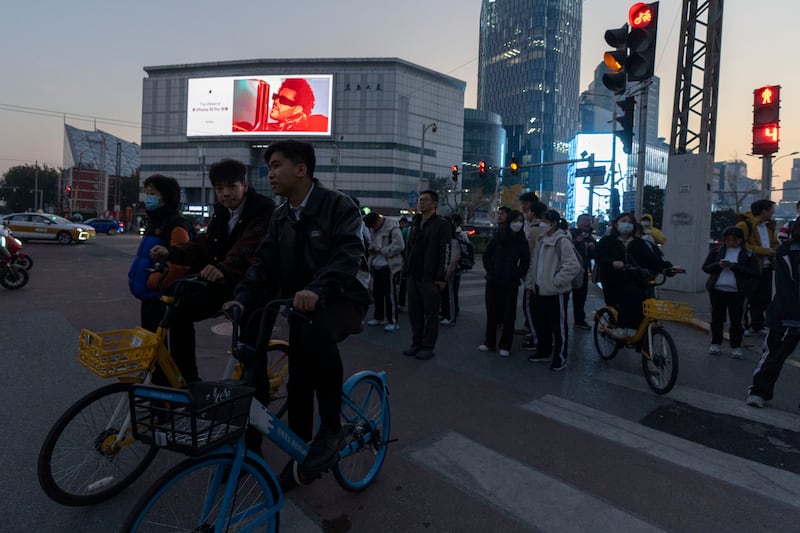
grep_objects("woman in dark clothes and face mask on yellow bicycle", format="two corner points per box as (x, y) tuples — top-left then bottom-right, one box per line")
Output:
(594, 213), (672, 338)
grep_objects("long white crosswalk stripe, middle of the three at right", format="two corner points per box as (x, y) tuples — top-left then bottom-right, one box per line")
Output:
(522, 395), (800, 508)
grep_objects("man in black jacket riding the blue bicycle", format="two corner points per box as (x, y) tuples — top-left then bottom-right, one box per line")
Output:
(224, 140), (369, 486)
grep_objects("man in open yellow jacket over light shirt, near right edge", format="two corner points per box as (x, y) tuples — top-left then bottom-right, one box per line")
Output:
(736, 199), (778, 336)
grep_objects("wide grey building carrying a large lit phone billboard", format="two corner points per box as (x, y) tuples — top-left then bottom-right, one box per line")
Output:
(141, 58), (466, 215)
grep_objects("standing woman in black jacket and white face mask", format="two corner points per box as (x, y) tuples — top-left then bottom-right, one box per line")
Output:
(478, 211), (530, 357)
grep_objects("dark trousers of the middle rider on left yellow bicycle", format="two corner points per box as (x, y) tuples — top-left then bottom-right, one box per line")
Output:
(169, 283), (233, 383)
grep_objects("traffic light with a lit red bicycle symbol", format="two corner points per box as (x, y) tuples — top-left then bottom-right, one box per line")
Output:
(625, 2), (658, 81)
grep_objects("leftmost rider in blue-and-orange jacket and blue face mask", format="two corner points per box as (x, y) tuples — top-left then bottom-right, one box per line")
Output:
(128, 174), (191, 331)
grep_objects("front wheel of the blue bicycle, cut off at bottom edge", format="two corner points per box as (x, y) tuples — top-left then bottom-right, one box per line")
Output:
(122, 453), (280, 533)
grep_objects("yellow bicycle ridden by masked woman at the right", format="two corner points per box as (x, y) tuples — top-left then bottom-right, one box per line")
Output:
(594, 266), (692, 394)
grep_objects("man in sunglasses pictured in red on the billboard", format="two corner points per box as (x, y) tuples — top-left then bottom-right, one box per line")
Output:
(268, 78), (328, 133)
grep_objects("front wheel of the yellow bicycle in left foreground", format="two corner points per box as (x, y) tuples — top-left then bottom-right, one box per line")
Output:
(37, 383), (158, 506)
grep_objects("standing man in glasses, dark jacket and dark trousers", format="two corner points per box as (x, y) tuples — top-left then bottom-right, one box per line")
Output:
(403, 190), (453, 360)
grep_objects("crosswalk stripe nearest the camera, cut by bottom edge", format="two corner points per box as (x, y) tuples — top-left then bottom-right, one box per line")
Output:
(408, 432), (662, 532)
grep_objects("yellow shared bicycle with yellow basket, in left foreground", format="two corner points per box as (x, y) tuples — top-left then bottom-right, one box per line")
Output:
(37, 276), (289, 506)
